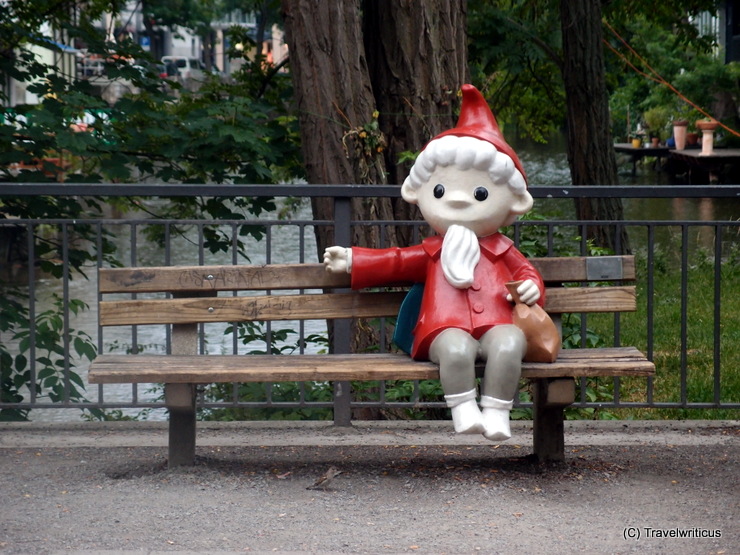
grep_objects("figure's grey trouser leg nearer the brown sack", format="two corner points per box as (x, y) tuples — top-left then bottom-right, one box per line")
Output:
(480, 325), (527, 401)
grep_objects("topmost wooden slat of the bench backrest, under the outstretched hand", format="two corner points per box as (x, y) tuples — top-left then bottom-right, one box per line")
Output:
(98, 256), (635, 293)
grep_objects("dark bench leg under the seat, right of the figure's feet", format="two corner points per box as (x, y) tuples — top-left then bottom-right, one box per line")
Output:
(533, 378), (576, 462)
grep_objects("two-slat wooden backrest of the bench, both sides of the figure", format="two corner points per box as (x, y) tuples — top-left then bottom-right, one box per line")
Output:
(98, 256), (637, 326)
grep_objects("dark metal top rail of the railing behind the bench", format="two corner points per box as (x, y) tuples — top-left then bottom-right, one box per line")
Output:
(0, 183), (740, 198)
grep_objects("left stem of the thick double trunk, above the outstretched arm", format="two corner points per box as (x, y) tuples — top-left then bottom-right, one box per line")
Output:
(282, 0), (392, 258)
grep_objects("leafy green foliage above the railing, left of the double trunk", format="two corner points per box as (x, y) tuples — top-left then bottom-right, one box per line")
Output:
(0, 0), (302, 226)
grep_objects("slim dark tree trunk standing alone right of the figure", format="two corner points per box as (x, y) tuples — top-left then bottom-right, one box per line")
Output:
(560, 0), (630, 253)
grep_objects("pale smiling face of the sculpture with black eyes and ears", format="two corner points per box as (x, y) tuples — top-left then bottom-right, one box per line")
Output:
(401, 165), (532, 237)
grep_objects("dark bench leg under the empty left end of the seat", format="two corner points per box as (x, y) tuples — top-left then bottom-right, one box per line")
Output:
(164, 383), (195, 468)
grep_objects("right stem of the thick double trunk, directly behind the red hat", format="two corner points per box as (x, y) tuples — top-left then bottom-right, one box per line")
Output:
(363, 0), (468, 239)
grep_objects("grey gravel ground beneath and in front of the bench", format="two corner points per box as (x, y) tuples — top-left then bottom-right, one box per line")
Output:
(0, 422), (740, 554)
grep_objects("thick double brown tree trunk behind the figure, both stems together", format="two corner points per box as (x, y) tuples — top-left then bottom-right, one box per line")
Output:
(282, 0), (467, 418)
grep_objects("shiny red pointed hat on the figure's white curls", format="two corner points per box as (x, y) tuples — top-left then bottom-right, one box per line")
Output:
(432, 85), (527, 181)
